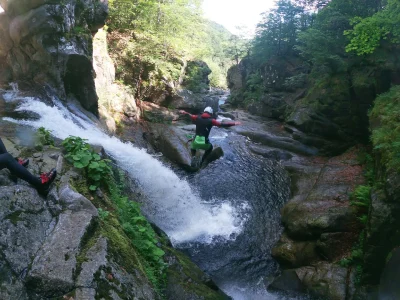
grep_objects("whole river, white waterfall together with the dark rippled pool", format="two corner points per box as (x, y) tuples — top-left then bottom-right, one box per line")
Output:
(0, 91), (306, 300)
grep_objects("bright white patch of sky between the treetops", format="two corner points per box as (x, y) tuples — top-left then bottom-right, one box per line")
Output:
(203, 0), (275, 34)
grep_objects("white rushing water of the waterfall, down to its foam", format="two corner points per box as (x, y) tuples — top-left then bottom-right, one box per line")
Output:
(4, 98), (246, 244)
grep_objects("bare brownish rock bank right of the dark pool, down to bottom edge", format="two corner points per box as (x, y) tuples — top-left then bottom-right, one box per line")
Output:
(271, 147), (363, 299)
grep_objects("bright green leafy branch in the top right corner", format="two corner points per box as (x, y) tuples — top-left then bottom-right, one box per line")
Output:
(344, 0), (400, 55)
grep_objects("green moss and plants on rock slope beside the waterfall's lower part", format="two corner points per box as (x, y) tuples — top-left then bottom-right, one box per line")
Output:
(62, 138), (166, 295)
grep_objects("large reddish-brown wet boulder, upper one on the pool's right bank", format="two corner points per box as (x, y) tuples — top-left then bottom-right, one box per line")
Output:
(281, 151), (363, 239)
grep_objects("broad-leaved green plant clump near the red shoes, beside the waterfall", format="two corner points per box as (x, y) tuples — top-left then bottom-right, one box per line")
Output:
(62, 136), (111, 191)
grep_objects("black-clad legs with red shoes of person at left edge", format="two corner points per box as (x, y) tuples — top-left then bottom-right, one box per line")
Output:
(0, 138), (57, 194)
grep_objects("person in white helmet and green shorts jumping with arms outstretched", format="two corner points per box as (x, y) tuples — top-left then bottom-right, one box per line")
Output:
(179, 106), (241, 163)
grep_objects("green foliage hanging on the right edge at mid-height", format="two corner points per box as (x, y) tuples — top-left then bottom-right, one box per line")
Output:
(369, 86), (400, 172)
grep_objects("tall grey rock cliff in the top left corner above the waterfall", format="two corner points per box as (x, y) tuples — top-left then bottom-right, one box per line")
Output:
(0, 0), (108, 113)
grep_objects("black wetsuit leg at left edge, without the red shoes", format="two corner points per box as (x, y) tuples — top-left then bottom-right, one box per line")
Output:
(0, 138), (42, 188)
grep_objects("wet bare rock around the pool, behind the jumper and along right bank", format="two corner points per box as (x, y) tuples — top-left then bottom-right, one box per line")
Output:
(132, 103), (364, 299)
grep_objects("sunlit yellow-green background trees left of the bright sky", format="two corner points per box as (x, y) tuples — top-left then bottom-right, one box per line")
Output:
(108, 0), (231, 94)
